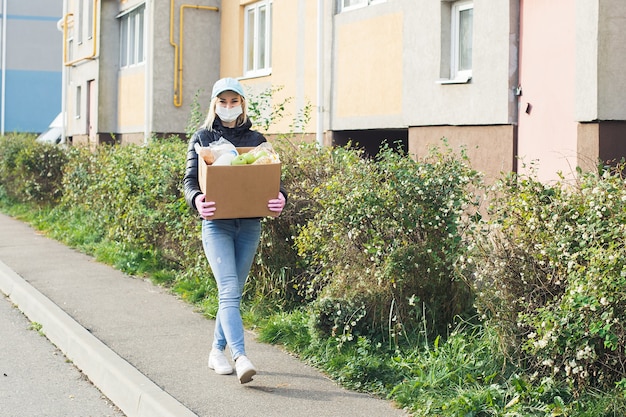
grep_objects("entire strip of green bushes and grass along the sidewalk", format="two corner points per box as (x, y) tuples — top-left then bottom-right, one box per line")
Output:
(0, 135), (626, 417)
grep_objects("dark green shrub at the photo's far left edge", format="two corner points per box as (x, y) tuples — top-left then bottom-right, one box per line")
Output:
(0, 134), (70, 204)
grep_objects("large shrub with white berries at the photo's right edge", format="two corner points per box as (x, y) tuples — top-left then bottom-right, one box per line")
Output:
(465, 162), (626, 392)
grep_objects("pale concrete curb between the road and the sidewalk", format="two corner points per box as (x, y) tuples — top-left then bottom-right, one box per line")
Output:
(0, 261), (198, 417)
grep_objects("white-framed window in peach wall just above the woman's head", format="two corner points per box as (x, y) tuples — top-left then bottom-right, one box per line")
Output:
(243, 0), (274, 77)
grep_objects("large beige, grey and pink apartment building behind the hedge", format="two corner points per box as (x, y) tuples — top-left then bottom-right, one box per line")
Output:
(62, 0), (626, 180)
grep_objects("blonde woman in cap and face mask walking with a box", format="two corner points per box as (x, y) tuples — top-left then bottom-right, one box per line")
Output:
(184, 78), (286, 384)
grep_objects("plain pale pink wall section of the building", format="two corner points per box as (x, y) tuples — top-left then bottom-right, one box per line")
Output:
(518, 0), (577, 181)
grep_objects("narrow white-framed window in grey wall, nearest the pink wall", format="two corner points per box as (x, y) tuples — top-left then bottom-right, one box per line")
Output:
(450, 1), (474, 82)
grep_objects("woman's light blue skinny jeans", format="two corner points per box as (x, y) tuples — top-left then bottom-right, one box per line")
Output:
(202, 219), (261, 360)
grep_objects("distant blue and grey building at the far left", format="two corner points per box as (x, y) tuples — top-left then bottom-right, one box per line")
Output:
(0, 0), (63, 135)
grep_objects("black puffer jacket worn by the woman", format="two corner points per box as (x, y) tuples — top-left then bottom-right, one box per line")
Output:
(183, 119), (287, 210)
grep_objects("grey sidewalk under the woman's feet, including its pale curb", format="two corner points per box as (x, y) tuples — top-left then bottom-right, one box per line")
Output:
(0, 214), (407, 417)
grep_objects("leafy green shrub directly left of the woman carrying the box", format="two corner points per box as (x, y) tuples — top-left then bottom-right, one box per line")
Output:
(56, 138), (202, 272)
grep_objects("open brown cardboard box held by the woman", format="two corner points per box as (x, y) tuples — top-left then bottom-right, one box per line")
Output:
(198, 148), (281, 219)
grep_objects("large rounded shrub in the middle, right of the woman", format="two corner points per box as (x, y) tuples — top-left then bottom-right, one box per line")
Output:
(296, 141), (479, 342)
